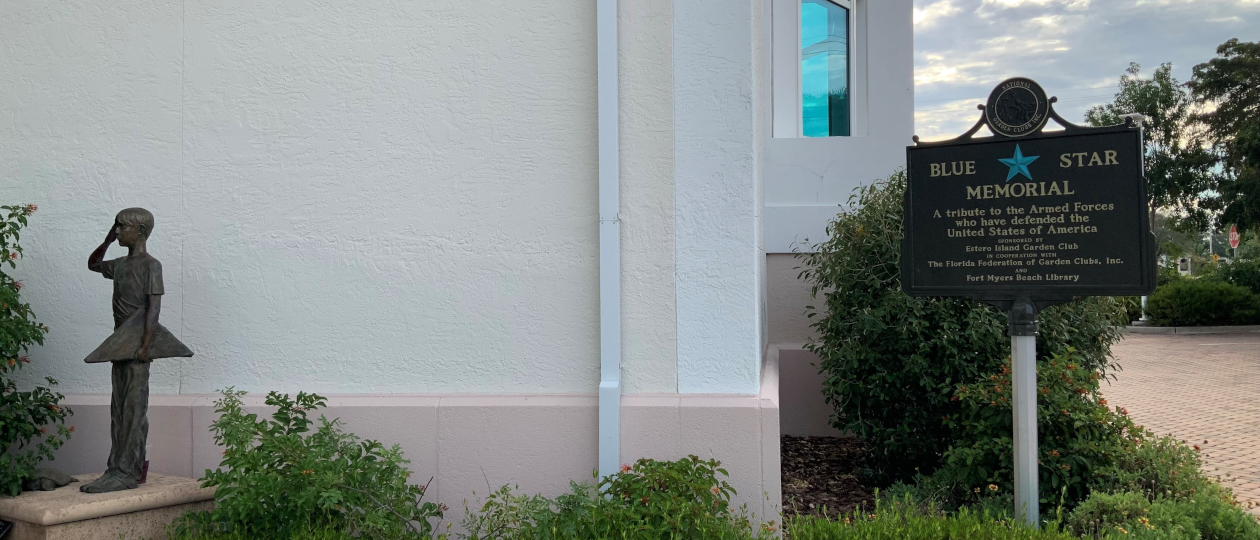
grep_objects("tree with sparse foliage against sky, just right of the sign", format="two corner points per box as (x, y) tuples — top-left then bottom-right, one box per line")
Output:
(1085, 63), (1217, 232)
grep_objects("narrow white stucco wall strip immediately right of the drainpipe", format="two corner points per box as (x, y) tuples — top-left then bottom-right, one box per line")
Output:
(617, 0), (678, 394)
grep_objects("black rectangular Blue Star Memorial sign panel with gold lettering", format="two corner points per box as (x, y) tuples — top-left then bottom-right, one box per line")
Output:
(902, 128), (1154, 298)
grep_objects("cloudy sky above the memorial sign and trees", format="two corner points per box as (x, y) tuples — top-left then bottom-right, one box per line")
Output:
(915, 0), (1260, 140)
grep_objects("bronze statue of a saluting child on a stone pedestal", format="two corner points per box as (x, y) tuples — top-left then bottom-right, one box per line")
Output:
(79, 208), (193, 493)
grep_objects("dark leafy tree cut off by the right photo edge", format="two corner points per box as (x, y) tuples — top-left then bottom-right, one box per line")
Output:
(1188, 39), (1260, 230)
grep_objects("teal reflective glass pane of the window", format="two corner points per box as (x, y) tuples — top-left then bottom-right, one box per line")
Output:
(800, 0), (849, 137)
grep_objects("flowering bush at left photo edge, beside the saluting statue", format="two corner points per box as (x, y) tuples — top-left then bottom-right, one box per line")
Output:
(0, 204), (74, 496)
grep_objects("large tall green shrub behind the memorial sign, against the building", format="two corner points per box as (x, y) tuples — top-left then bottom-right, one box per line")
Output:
(800, 172), (1128, 482)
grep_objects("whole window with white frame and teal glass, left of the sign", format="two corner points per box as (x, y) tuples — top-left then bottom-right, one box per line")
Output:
(771, 0), (866, 137)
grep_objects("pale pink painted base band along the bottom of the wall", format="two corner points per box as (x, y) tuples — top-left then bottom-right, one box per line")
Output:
(48, 365), (781, 531)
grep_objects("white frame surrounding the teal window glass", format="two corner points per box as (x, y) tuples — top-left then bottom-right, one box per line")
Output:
(770, 0), (868, 138)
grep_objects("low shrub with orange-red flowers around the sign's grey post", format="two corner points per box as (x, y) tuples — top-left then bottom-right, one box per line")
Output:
(934, 350), (1144, 507)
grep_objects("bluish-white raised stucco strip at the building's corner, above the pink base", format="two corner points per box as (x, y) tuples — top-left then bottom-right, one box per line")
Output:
(673, 0), (765, 394)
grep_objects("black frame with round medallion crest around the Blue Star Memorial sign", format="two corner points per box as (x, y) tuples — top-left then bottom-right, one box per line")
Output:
(901, 78), (1157, 303)
